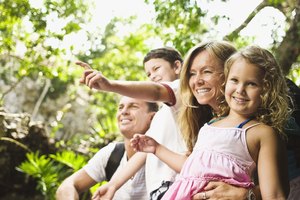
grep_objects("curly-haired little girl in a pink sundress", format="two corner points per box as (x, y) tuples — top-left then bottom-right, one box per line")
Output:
(131, 46), (289, 200)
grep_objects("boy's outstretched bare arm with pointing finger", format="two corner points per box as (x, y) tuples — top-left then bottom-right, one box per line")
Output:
(76, 61), (172, 102)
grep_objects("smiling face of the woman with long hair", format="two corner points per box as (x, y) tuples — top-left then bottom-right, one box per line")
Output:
(189, 50), (223, 110)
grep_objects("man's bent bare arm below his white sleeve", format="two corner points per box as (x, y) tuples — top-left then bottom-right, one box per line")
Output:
(56, 169), (97, 200)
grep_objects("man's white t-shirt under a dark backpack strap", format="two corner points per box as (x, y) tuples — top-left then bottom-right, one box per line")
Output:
(83, 143), (149, 200)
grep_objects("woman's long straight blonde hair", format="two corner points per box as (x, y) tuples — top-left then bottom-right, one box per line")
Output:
(178, 41), (236, 151)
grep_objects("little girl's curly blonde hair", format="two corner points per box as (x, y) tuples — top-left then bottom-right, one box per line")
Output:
(220, 45), (291, 138)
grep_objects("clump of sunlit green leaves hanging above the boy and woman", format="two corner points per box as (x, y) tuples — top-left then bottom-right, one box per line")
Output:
(146, 0), (208, 55)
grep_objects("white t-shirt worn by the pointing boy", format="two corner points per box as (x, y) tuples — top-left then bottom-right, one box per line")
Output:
(145, 80), (187, 195)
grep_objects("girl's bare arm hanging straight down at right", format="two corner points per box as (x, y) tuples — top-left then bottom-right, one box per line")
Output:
(254, 125), (289, 199)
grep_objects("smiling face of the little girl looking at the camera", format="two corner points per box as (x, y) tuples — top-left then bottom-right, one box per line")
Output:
(225, 59), (264, 117)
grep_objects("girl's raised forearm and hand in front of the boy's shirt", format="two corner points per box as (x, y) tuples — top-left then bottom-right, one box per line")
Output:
(130, 134), (187, 173)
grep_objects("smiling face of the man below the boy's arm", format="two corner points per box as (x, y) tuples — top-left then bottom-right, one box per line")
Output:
(117, 97), (155, 139)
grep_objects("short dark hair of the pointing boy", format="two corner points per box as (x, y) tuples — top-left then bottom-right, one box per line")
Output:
(143, 47), (183, 64)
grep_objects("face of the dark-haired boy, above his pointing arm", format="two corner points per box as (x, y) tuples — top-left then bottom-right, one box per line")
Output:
(144, 58), (181, 82)
